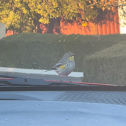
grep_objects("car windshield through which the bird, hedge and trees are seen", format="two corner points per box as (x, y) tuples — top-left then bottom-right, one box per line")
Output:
(0, 0), (126, 86)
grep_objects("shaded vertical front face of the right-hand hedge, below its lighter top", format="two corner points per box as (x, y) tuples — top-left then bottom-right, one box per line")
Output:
(83, 57), (126, 86)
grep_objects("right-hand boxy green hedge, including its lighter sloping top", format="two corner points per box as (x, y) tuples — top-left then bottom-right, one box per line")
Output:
(83, 41), (126, 86)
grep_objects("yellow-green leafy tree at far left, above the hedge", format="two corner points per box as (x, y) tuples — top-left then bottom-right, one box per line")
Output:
(0, 0), (38, 32)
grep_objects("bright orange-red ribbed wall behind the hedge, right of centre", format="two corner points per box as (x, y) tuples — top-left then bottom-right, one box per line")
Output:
(60, 9), (120, 35)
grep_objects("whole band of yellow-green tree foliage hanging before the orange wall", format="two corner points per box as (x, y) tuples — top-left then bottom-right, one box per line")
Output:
(0, 0), (112, 32)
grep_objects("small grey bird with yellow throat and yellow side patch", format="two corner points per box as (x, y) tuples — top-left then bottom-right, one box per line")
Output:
(52, 52), (75, 82)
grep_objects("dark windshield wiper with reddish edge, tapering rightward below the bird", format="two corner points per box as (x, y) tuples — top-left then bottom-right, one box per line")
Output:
(0, 75), (116, 86)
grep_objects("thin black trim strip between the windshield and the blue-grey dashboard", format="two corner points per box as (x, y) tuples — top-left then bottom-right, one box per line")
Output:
(0, 85), (126, 91)
